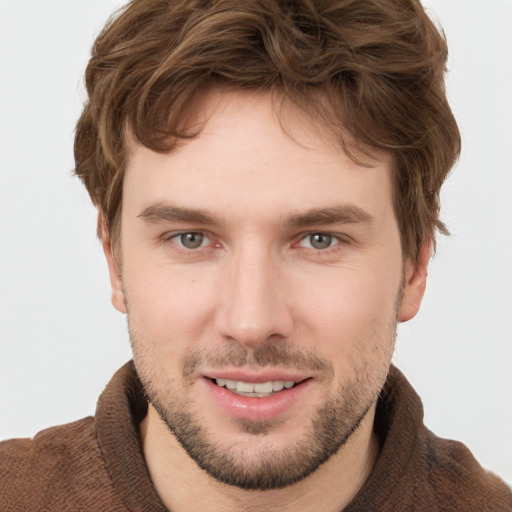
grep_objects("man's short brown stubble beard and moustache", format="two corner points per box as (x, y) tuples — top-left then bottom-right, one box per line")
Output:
(131, 332), (396, 490)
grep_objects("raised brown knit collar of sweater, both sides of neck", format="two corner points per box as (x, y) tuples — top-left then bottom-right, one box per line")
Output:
(95, 361), (425, 512)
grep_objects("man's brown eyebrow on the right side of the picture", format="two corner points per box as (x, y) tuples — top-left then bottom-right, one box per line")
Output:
(285, 205), (374, 227)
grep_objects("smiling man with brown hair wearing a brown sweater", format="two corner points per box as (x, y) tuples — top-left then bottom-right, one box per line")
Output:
(0, 0), (512, 511)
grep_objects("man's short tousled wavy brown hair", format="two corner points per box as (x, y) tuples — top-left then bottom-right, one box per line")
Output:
(75, 0), (460, 259)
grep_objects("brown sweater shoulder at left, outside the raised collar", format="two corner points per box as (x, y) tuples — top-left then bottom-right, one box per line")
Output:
(0, 417), (125, 512)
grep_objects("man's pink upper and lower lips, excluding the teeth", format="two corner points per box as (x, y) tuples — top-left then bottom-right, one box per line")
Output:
(203, 371), (312, 421)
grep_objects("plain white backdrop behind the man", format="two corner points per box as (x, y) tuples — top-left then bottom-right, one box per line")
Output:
(0, 0), (512, 483)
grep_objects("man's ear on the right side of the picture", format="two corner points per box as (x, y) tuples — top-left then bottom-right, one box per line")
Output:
(398, 242), (432, 322)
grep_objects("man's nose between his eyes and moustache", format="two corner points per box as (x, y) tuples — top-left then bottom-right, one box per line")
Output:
(216, 244), (293, 348)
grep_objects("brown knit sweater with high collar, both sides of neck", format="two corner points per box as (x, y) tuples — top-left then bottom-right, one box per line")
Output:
(0, 362), (512, 512)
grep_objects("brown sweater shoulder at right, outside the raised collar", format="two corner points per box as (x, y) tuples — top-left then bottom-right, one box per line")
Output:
(424, 429), (512, 512)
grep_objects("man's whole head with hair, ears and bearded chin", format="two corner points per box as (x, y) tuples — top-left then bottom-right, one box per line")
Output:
(75, 0), (460, 488)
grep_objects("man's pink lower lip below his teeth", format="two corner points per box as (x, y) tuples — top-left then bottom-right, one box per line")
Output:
(205, 378), (311, 421)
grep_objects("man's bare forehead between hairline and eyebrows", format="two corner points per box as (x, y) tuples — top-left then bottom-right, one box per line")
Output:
(123, 90), (391, 221)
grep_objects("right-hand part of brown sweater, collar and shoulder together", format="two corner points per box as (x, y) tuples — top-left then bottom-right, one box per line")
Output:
(358, 367), (512, 512)
